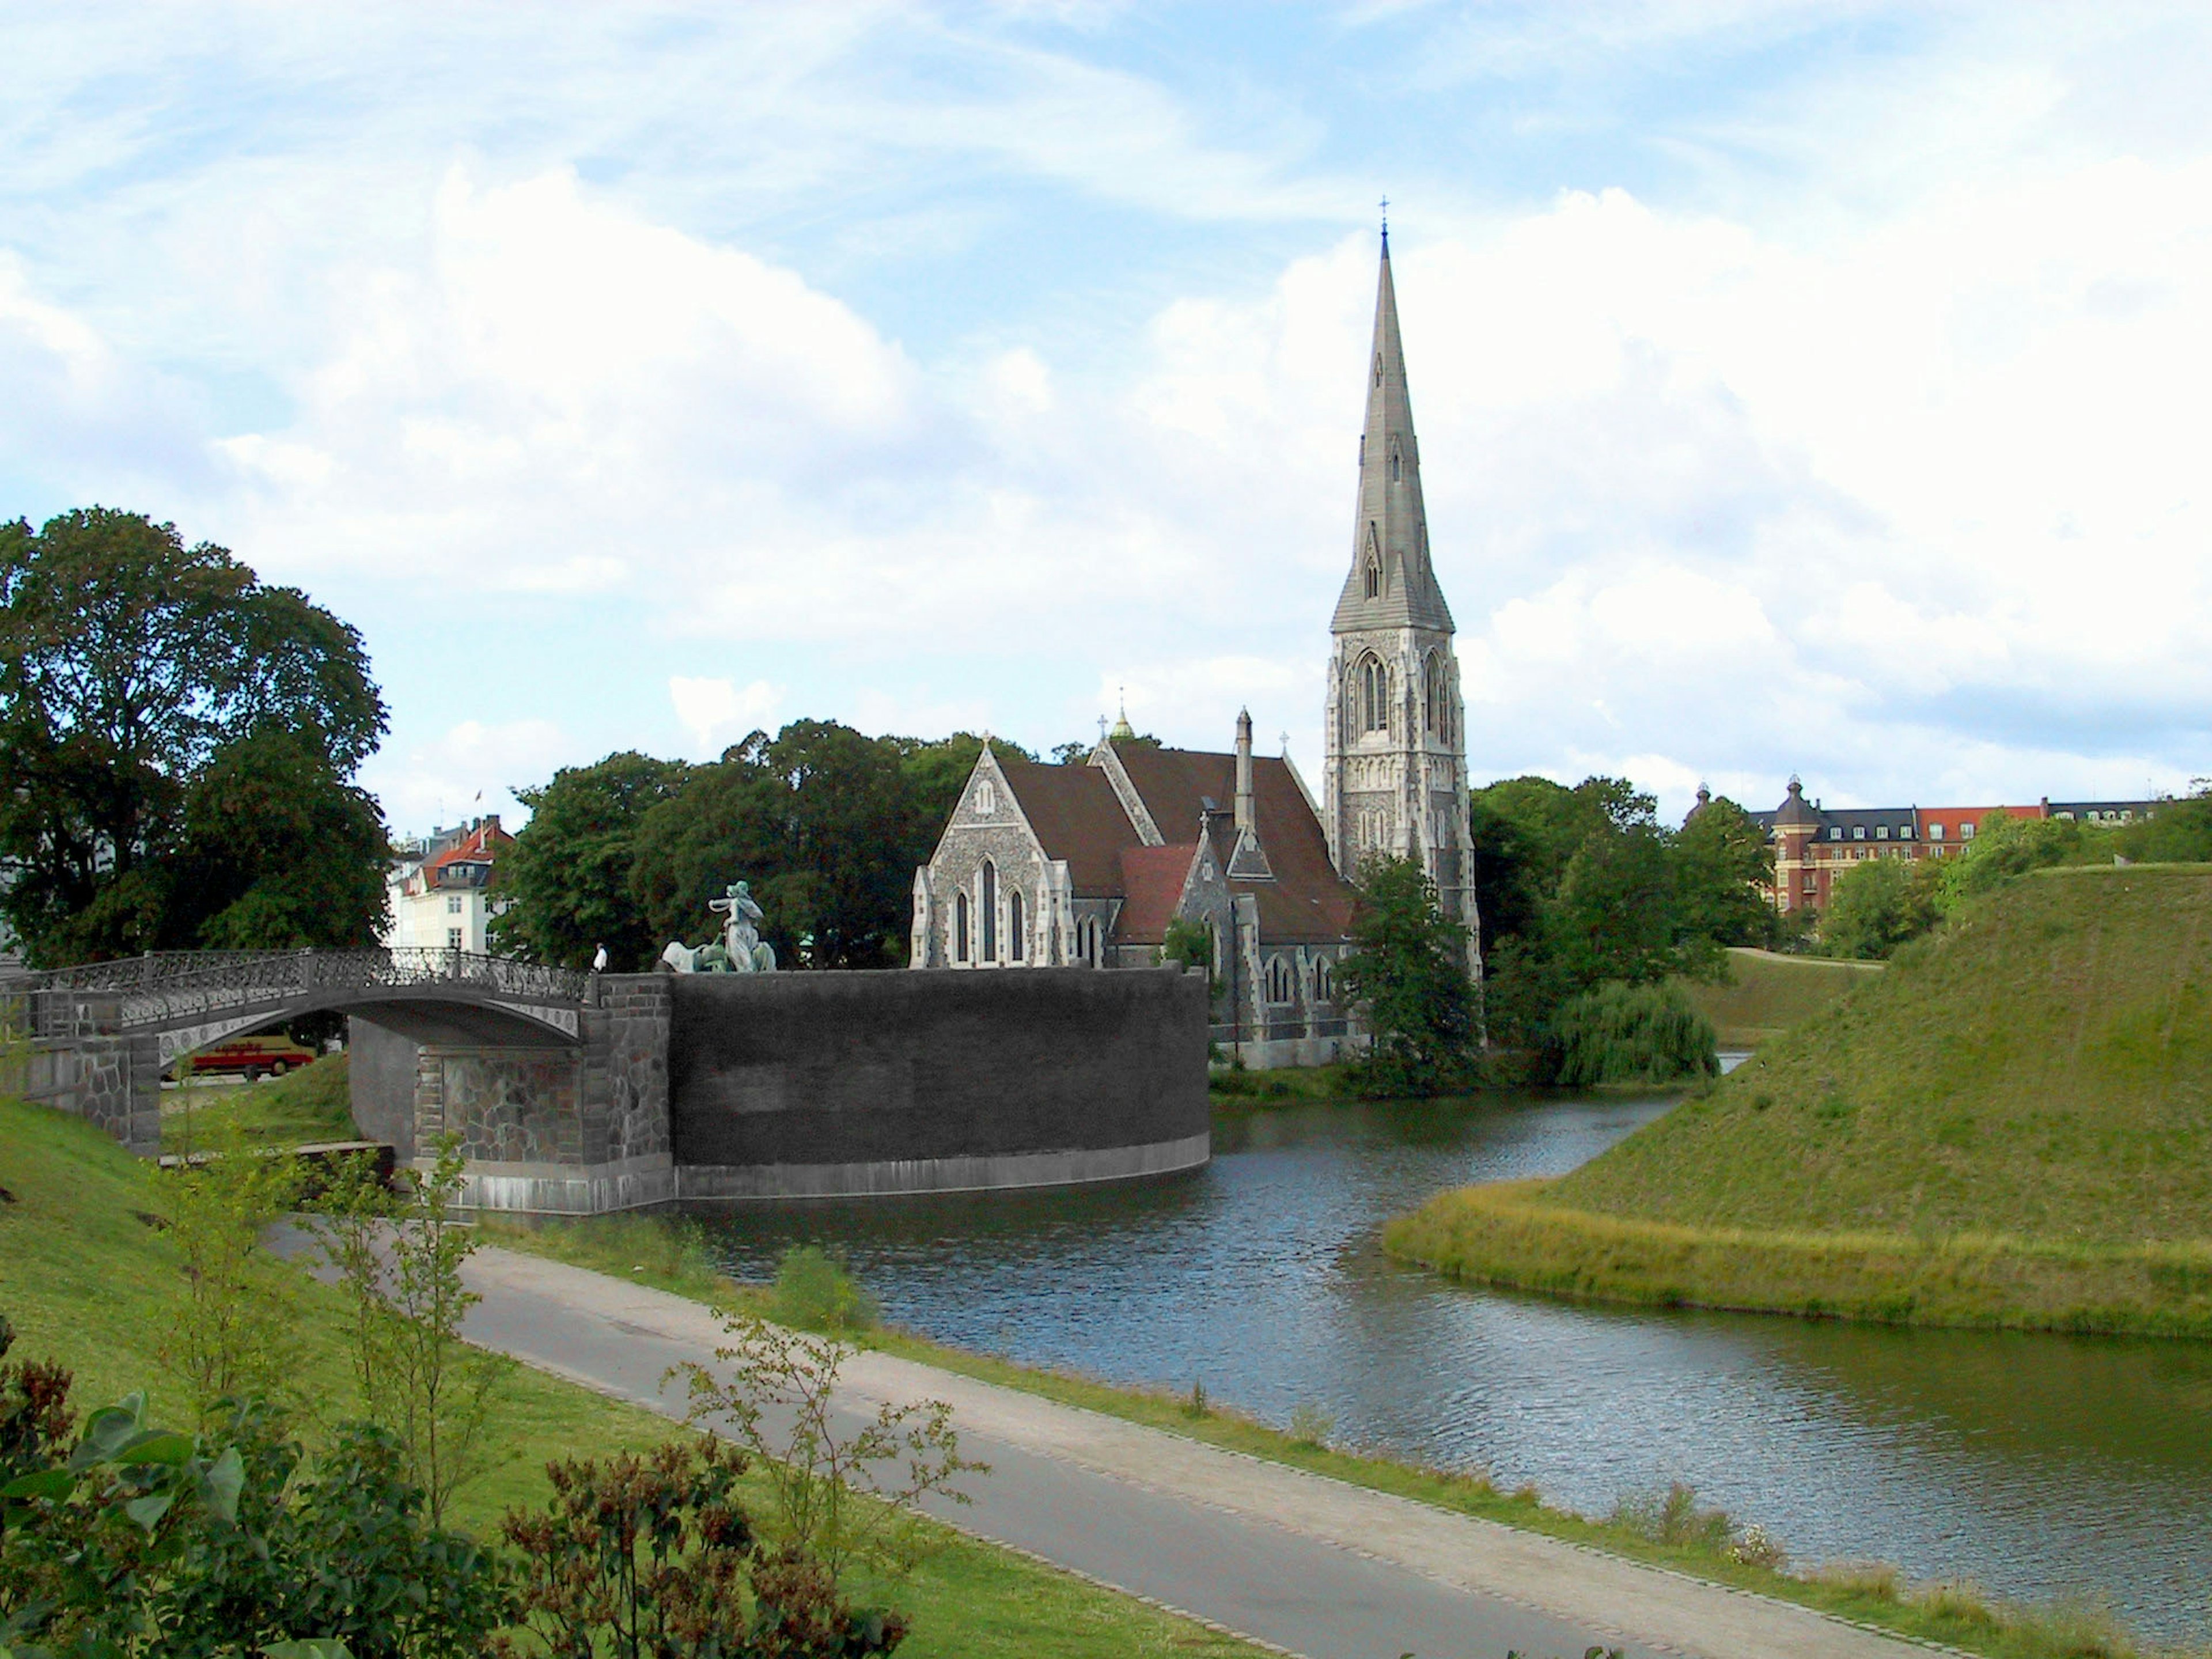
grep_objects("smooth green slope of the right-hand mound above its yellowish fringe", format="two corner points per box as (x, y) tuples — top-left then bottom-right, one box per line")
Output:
(1575, 869), (2212, 1243)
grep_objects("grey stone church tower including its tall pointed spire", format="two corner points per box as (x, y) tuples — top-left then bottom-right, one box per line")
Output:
(1323, 226), (1482, 978)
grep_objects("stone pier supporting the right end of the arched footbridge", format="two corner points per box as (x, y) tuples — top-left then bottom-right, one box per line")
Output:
(347, 974), (675, 1214)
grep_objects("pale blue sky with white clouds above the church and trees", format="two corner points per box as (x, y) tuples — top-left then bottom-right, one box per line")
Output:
(0, 0), (2212, 832)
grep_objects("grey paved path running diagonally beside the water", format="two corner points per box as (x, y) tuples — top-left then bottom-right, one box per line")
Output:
(453, 1250), (1927, 1659)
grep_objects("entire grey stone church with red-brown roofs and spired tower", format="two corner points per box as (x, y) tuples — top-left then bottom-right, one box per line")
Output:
(909, 228), (1482, 1066)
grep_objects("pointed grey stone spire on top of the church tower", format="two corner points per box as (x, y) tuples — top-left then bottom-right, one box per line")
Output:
(1332, 228), (1451, 632)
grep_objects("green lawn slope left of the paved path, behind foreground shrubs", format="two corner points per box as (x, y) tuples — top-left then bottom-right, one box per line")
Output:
(0, 1106), (1259, 1659)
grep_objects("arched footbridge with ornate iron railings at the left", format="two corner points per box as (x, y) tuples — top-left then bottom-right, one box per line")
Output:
(5, 949), (623, 1153)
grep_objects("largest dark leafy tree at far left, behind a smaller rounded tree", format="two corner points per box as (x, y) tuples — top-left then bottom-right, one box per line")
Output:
(0, 506), (385, 964)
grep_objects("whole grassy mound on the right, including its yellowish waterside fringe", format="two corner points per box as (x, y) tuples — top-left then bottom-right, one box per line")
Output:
(1385, 867), (2212, 1336)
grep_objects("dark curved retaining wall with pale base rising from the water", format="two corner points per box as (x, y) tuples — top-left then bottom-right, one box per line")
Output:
(668, 969), (1208, 1196)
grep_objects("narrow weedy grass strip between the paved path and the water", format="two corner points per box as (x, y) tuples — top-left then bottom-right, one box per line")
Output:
(484, 1214), (2212, 1659)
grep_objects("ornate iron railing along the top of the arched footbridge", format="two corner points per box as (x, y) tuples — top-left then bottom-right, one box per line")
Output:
(22, 947), (590, 1029)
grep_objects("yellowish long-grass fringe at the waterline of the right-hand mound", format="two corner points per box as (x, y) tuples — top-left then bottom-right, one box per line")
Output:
(1382, 1181), (2212, 1338)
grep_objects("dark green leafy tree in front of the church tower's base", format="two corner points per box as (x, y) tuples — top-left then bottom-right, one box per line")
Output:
(1340, 858), (1482, 1095)
